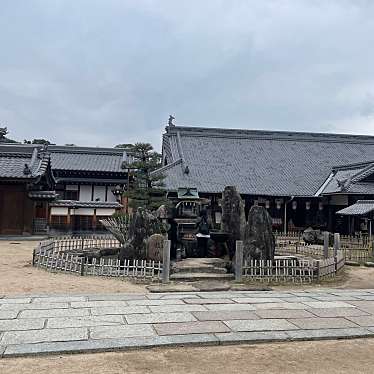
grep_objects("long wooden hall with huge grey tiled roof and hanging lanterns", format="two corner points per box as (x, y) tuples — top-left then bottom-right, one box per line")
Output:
(157, 125), (374, 233)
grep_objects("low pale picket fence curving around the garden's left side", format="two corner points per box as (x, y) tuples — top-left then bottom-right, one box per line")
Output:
(33, 237), (164, 281)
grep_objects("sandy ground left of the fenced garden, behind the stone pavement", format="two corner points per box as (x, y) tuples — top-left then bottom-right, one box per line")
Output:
(0, 241), (146, 295)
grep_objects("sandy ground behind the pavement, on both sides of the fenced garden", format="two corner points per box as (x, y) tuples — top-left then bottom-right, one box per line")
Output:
(0, 240), (374, 295)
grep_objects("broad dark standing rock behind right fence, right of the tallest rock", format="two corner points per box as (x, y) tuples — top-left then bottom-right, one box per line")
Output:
(243, 206), (275, 260)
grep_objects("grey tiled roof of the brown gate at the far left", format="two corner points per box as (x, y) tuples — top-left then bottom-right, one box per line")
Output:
(0, 145), (49, 179)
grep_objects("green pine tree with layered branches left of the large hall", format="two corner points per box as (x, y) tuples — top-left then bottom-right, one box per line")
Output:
(124, 143), (167, 210)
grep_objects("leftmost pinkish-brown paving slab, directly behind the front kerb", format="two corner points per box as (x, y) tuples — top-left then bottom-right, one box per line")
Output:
(153, 321), (230, 335)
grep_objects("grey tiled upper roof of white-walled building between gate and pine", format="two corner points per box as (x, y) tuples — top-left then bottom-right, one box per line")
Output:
(48, 146), (127, 173)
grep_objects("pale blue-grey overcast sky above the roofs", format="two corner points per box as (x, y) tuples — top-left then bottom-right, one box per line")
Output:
(0, 0), (374, 149)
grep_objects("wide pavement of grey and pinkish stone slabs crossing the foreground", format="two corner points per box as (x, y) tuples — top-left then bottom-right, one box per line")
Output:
(0, 289), (374, 357)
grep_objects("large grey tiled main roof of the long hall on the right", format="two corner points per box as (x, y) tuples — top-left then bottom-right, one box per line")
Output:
(157, 126), (374, 196)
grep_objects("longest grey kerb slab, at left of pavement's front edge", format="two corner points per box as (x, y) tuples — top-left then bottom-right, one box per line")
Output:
(4, 334), (219, 357)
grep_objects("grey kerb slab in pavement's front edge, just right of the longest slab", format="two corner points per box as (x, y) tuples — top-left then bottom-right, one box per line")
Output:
(215, 331), (289, 344)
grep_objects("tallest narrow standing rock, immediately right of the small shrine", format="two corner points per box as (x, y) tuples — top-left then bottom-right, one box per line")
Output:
(221, 186), (245, 258)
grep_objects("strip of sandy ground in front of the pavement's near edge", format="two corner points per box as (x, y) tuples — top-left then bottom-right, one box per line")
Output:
(0, 339), (374, 374)
